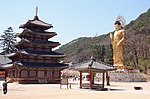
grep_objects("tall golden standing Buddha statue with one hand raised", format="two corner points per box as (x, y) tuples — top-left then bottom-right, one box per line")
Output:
(110, 17), (125, 67)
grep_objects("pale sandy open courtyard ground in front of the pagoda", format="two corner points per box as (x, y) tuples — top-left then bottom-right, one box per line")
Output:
(0, 81), (150, 99)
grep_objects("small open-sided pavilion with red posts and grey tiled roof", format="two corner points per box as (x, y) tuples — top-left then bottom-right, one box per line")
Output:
(70, 58), (116, 89)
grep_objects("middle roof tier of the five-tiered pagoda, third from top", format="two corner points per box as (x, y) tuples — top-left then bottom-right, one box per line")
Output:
(14, 39), (60, 47)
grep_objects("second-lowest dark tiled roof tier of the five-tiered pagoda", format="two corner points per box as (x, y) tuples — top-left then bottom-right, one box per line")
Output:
(5, 50), (65, 58)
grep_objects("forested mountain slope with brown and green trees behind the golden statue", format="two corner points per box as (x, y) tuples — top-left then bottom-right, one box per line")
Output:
(57, 9), (150, 70)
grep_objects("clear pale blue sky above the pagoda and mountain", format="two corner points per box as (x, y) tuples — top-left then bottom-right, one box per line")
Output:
(0, 0), (150, 45)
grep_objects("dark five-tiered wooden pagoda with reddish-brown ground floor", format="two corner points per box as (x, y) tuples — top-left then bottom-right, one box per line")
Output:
(4, 8), (68, 83)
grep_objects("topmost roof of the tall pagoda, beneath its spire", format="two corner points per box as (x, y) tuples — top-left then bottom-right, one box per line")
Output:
(19, 16), (53, 30)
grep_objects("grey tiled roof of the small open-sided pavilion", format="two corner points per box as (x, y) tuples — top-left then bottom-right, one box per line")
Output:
(70, 60), (116, 72)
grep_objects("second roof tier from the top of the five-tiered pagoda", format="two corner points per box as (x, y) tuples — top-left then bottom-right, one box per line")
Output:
(18, 29), (57, 37)
